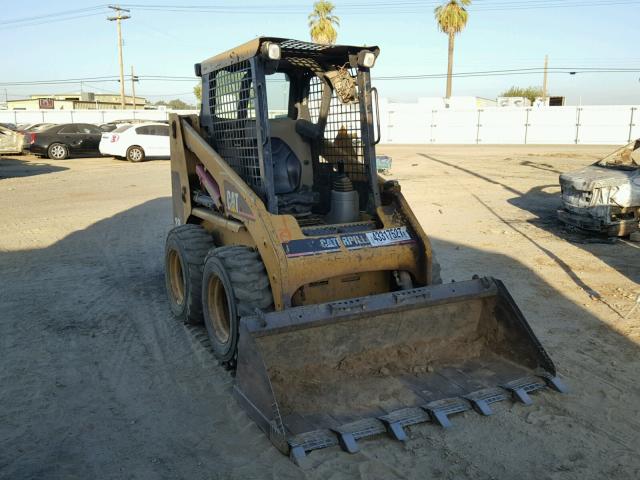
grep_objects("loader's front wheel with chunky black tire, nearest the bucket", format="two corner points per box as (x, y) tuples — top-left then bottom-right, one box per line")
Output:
(202, 245), (273, 369)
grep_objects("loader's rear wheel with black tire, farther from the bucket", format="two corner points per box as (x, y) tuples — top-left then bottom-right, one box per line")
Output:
(164, 225), (214, 325)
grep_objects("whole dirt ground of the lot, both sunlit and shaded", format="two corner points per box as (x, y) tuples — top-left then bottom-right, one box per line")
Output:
(0, 146), (640, 480)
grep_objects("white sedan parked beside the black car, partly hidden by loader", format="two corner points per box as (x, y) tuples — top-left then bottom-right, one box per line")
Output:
(100, 122), (169, 162)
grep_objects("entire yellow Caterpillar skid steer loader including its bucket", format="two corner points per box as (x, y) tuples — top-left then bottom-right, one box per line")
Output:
(165, 37), (564, 463)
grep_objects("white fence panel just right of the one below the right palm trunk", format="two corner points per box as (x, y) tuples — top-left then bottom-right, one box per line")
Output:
(478, 108), (527, 144)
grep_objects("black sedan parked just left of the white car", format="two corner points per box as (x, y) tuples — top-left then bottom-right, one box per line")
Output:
(29, 123), (102, 160)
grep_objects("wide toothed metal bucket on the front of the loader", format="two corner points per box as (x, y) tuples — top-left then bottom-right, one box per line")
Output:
(235, 278), (563, 463)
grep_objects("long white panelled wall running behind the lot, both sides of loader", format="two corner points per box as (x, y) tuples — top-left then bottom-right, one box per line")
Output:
(0, 102), (640, 144)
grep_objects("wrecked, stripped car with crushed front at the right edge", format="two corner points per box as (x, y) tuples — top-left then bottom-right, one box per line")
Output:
(558, 139), (640, 237)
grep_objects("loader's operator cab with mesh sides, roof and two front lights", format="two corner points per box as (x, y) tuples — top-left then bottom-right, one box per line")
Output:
(196, 37), (380, 226)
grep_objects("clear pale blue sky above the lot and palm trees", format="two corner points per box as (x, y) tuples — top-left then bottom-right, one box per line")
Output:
(0, 0), (640, 104)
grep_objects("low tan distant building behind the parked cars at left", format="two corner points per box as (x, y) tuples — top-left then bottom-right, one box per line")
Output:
(7, 92), (147, 110)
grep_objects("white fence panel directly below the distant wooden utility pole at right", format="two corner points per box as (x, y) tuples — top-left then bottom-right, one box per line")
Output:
(525, 107), (578, 144)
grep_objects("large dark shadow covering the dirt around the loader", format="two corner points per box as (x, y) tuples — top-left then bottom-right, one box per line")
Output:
(0, 197), (640, 480)
